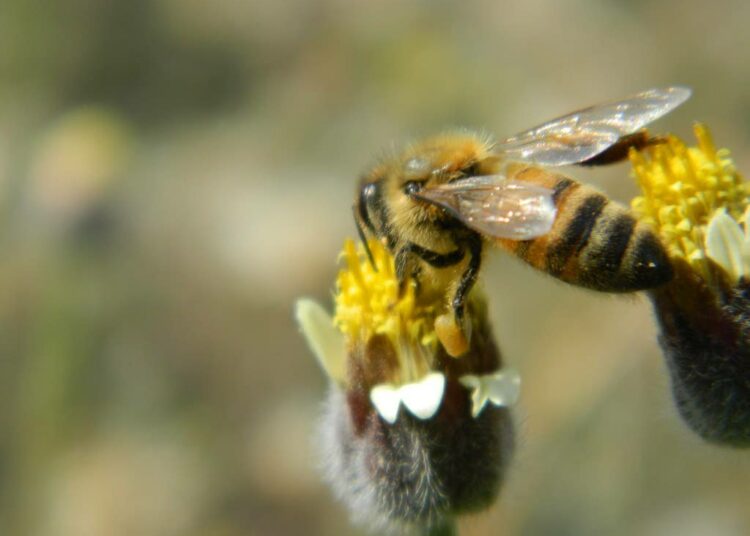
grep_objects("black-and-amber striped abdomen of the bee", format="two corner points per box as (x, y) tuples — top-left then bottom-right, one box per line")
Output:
(498, 168), (672, 292)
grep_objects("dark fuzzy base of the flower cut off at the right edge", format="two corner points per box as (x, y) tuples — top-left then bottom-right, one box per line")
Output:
(652, 262), (750, 447)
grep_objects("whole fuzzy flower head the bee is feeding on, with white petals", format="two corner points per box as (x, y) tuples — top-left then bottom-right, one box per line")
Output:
(297, 242), (519, 533)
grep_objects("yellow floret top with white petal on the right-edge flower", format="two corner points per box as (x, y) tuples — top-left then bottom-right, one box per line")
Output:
(630, 123), (750, 284)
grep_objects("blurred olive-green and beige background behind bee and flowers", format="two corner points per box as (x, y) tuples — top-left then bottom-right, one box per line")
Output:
(0, 0), (750, 536)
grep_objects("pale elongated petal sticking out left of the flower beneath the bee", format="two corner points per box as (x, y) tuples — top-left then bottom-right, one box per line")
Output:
(294, 298), (346, 384)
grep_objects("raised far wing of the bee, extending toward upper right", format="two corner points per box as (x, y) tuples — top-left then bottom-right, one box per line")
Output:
(497, 86), (691, 166)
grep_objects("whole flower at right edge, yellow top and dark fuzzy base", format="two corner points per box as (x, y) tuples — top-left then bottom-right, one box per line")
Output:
(631, 125), (750, 446)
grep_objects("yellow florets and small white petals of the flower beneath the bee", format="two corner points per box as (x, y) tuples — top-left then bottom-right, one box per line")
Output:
(296, 240), (518, 424)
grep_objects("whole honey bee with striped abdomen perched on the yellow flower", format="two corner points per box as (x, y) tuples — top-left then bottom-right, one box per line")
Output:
(354, 87), (690, 350)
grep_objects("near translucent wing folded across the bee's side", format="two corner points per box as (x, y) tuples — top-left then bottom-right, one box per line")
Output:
(413, 175), (557, 240)
